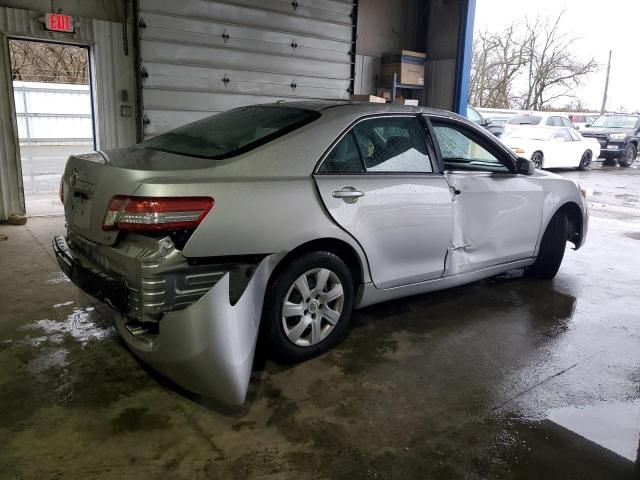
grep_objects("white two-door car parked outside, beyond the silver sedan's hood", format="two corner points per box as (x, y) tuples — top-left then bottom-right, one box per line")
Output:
(501, 127), (600, 170)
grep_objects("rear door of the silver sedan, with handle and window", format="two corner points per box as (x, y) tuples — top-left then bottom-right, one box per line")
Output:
(315, 115), (452, 288)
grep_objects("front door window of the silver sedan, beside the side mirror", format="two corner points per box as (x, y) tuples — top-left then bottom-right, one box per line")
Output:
(433, 122), (509, 172)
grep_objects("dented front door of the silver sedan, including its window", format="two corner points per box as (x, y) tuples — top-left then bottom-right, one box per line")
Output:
(432, 119), (543, 275)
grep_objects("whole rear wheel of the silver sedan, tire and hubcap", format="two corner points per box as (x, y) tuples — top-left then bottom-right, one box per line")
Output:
(264, 251), (354, 363)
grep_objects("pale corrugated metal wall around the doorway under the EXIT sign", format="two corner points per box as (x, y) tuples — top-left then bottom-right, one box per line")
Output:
(0, 7), (135, 221)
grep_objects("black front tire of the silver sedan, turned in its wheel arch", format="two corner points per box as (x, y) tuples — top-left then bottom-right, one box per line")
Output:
(529, 212), (569, 280)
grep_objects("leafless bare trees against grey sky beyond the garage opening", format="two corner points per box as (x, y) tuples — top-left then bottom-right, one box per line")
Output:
(469, 12), (598, 110)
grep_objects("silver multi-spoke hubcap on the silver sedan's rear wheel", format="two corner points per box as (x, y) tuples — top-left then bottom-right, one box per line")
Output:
(282, 268), (344, 347)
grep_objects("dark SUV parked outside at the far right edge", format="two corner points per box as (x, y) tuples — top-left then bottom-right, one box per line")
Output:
(581, 114), (640, 167)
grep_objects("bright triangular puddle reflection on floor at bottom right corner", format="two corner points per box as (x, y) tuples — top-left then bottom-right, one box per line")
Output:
(548, 399), (640, 462)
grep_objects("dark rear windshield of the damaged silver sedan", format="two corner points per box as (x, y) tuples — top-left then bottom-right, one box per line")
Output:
(142, 105), (320, 159)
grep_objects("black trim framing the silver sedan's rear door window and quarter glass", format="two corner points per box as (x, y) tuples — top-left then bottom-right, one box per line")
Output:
(312, 112), (442, 177)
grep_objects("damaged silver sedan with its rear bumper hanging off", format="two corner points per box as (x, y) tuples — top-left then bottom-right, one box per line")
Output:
(53, 102), (588, 405)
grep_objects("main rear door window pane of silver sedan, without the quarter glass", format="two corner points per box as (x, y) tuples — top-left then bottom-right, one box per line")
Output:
(353, 117), (433, 173)
